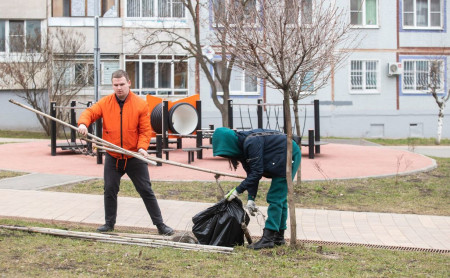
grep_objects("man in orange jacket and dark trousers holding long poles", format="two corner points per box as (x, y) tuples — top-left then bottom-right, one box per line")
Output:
(78, 70), (174, 235)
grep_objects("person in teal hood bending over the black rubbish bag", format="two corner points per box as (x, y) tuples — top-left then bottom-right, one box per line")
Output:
(212, 127), (301, 250)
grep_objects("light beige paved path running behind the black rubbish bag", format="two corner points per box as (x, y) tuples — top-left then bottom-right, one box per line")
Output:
(0, 189), (450, 252)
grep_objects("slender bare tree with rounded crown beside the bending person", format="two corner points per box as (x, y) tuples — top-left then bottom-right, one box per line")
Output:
(216, 0), (356, 246)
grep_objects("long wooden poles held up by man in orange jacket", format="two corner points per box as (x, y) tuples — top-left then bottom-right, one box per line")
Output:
(9, 99), (245, 179)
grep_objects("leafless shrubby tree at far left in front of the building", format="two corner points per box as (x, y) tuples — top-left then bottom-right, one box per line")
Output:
(0, 28), (90, 135)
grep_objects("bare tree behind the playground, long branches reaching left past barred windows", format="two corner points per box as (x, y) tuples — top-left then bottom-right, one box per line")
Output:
(131, 0), (235, 127)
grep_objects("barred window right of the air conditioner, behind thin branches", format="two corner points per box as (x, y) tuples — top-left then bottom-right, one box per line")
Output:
(403, 59), (444, 93)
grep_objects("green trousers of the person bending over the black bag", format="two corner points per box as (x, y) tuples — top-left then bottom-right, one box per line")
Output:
(265, 142), (302, 232)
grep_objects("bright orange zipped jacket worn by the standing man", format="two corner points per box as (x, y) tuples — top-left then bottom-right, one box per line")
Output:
(78, 91), (151, 158)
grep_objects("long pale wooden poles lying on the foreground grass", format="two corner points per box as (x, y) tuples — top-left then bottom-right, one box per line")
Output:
(0, 225), (233, 253)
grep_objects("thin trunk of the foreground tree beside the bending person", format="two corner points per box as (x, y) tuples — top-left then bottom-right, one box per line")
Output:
(283, 90), (297, 248)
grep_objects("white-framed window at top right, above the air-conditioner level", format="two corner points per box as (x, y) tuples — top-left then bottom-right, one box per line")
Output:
(403, 0), (443, 28)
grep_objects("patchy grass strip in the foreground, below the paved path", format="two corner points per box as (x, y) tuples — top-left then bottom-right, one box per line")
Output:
(0, 219), (450, 278)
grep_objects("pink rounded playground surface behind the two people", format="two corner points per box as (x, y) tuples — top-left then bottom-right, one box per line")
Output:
(0, 138), (436, 181)
